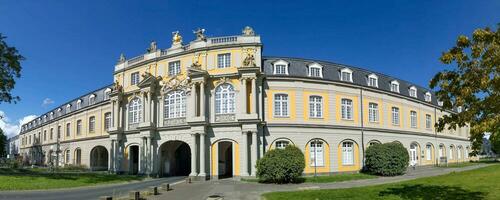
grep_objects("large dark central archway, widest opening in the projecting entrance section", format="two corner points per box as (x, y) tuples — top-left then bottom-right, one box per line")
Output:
(160, 141), (191, 176)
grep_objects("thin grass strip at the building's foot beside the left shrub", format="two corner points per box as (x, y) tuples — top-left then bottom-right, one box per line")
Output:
(241, 173), (377, 183)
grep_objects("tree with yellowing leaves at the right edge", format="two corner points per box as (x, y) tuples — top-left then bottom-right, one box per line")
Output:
(430, 23), (500, 154)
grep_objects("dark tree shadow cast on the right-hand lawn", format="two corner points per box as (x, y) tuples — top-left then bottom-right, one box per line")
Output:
(379, 184), (485, 200)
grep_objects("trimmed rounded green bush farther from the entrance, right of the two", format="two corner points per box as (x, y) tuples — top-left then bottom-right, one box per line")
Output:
(365, 142), (410, 176)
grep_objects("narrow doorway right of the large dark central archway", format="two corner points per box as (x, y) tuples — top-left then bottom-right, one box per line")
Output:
(217, 141), (233, 179)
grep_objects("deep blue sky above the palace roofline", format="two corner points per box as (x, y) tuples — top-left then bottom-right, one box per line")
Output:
(0, 0), (500, 137)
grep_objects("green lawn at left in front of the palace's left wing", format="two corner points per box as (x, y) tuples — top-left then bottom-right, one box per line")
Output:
(0, 169), (143, 191)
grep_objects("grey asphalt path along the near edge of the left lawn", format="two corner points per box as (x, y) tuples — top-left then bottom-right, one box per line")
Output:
(0, 177), (185, 200)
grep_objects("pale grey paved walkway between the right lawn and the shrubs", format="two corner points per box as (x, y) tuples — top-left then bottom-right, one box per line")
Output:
(148, 164), (487, 200)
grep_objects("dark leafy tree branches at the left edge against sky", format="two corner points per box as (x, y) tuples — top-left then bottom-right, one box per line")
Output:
(0, 33), (24, 103)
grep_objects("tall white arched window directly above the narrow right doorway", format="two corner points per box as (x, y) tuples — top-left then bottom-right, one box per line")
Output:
(215, 83), (235, 114)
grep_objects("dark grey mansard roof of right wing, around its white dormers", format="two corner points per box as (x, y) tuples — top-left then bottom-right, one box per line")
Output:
(262, 56), (438, 106)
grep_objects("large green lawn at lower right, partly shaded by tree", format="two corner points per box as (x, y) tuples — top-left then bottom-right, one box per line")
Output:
(263, 164), (500, 200)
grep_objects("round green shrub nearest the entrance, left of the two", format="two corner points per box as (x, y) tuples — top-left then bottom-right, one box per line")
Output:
(256, 145), (305, 183)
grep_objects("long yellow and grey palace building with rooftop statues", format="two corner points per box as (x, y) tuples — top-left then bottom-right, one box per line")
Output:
(19, 27), (470, 179)
